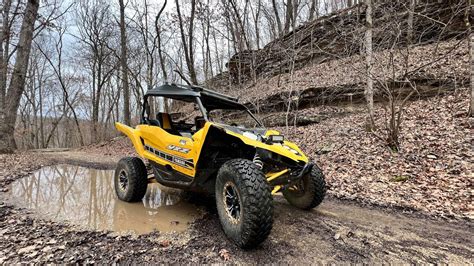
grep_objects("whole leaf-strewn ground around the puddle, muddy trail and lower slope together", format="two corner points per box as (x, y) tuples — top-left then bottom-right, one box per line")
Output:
(0, 91), (474, 264)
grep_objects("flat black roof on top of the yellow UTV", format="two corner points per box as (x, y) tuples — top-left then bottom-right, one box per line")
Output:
(145, 84), (246, 111)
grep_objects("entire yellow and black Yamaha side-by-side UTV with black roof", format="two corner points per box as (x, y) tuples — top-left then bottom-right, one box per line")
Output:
(114, 84), (326, 248)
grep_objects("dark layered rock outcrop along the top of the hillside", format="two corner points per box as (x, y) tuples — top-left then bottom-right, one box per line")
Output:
(211, 0), (465, 87)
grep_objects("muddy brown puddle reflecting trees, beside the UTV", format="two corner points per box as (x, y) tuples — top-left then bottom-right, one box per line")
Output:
(9, 165), (199, 234)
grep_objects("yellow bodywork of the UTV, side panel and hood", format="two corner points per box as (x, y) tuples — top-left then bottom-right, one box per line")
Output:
(115, 122), (308, 180)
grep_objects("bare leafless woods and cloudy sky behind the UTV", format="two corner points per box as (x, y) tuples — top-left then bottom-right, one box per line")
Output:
(0, 0), (474, 152)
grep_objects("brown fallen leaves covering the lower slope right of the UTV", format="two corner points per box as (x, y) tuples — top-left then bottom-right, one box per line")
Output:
(279, 90), (474, 218)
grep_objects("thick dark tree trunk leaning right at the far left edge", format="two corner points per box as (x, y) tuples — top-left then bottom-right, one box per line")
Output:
(0, 0), (39, 153)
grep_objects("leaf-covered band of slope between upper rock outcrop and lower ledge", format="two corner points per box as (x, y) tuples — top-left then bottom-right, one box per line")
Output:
(226, 40), (469, 112)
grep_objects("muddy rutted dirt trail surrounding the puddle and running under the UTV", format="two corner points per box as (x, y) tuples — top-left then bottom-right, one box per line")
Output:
(0, 151), (474, 264)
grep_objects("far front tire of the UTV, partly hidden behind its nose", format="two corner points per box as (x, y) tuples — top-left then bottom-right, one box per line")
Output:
(282, 165), (326, 210)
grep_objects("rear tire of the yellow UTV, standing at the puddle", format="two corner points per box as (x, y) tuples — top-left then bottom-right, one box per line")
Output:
(114, 157), (148, 202)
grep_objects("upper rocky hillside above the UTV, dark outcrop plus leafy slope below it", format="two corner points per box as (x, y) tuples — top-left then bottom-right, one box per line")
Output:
(209, 1), (469, 113)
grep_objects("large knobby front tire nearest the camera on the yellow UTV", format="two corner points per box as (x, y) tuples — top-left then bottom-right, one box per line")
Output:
(215, 159), (273, 248)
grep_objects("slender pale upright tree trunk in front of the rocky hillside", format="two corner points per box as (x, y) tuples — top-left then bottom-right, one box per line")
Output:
(365, 0), (374, 129)
